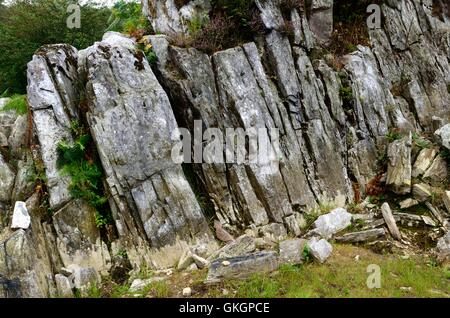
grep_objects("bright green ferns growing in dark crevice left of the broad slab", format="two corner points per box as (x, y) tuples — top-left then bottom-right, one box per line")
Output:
(57, 122), (112, 228)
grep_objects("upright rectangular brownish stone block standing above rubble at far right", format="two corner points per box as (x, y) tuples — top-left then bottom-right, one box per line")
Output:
(386, 134), (412, 194)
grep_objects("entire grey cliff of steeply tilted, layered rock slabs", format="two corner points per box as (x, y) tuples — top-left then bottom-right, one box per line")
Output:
(0, 0), (450, 297)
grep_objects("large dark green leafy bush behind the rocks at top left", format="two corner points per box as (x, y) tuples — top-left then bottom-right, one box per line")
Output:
(0, 0), (110, 93)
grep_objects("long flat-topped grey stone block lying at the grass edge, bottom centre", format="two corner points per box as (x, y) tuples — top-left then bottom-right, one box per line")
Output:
(205, 251), (279, 284)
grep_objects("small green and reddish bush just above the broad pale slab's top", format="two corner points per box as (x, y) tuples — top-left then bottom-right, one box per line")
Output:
(107, 0), (151, 34)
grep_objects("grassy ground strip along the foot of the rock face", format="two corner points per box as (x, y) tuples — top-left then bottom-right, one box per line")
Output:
(89, 245), (450, 298)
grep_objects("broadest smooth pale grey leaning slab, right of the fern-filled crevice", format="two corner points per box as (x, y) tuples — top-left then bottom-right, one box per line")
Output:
(79, 33), (216, 267)
